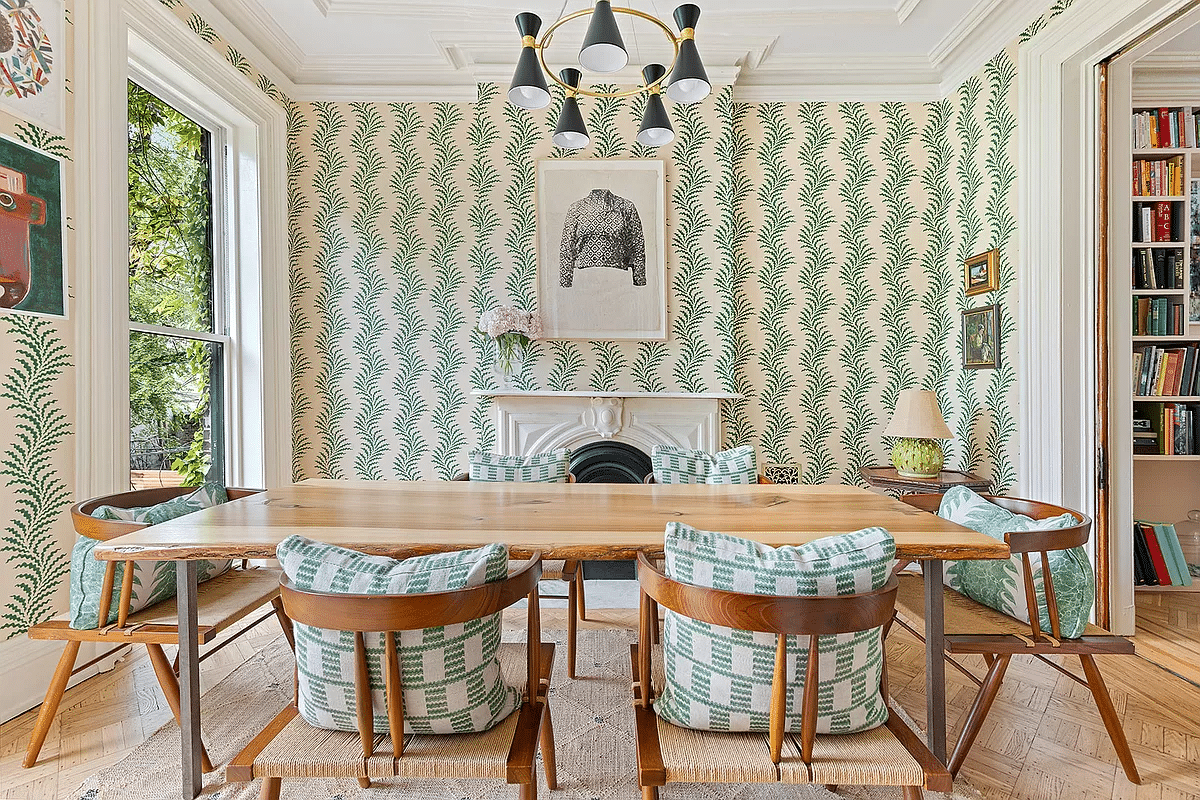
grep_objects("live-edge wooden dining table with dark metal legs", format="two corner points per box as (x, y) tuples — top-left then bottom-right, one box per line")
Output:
(95, 480), (1008, 800)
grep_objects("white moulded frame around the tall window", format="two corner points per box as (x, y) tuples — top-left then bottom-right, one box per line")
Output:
(76, 0), (292, 497)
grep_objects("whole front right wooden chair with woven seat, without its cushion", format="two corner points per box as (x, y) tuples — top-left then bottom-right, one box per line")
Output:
(630, 554), (952, 800)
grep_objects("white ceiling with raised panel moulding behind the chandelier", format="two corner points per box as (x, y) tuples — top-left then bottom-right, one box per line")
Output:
(196, 0), (1049, 100)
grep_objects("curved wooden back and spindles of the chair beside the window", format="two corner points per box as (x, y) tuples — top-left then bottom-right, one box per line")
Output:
(71, 486), (263, 627)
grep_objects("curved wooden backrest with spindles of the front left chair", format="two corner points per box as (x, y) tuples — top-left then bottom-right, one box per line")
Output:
(280, 551), (541, 758)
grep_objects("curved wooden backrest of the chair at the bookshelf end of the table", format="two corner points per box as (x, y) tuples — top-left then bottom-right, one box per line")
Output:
(900, 494), (1092, 642)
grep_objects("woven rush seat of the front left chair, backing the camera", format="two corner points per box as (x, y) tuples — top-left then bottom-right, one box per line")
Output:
(240, 644), (554, 781)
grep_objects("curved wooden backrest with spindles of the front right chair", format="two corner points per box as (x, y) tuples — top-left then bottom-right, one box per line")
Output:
(637, 553), (900, 764)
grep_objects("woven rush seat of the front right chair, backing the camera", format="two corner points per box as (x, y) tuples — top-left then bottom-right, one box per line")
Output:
(631, 645), (925, 787)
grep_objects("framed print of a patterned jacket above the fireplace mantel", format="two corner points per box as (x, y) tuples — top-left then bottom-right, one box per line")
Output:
(536, 158), (667, 339)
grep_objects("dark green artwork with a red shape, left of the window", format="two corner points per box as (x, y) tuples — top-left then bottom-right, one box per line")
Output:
(0, 137), (66, 317)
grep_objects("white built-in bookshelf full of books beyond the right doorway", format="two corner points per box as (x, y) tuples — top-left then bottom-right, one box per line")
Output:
(1124, 103), (1200, 593)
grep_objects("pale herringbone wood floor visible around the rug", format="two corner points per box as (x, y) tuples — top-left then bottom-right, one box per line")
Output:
(0, 604), (1200, 800)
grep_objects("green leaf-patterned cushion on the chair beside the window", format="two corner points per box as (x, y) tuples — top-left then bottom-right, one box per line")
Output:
(71, 483), (230, 630)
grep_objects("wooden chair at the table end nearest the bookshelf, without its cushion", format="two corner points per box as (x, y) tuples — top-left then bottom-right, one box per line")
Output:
(896, 494), (1141, 783)
